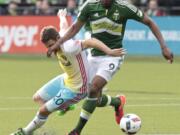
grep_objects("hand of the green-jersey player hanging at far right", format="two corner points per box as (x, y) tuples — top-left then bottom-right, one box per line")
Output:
(162, 47), (174, 63)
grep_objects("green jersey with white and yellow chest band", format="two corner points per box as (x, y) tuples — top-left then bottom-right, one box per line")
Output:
(78, 0), (144, 56)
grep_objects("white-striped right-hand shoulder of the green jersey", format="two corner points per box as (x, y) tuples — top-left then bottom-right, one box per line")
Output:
(115, 0), (138, 13)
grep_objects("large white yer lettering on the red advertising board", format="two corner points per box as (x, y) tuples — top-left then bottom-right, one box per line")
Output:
(0, 25), (38, 52)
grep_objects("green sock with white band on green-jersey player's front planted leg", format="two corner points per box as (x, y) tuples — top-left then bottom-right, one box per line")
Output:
(75, 98), (97, 133)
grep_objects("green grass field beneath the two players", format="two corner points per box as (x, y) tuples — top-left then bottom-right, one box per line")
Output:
(0, 56), (180, 135)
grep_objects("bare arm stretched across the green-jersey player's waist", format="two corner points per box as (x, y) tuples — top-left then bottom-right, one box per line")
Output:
(82, 38), (126, 56)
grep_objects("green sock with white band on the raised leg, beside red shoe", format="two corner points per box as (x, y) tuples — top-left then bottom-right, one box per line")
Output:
(97, 94), (121, 107)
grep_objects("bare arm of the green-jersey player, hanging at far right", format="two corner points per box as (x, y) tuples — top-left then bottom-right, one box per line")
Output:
(142, 14), (173, 63)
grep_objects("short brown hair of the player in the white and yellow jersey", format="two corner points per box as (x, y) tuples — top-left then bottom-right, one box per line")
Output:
(40, 26), (59, 43)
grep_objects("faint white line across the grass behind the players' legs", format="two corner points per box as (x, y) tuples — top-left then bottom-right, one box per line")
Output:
(0, 103), (180, 111)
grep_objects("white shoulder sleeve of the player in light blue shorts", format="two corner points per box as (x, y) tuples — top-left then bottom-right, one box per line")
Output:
(61, 39), (82, 55)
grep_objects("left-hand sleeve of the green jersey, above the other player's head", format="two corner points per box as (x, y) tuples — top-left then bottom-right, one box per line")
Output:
(78, 0), (89, 22)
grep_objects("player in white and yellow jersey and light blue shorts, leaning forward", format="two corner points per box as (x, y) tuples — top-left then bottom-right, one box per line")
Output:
(11, 10), (125, 135)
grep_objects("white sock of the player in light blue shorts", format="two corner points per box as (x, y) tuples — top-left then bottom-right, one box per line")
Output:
(23, 113), (47, 134)
